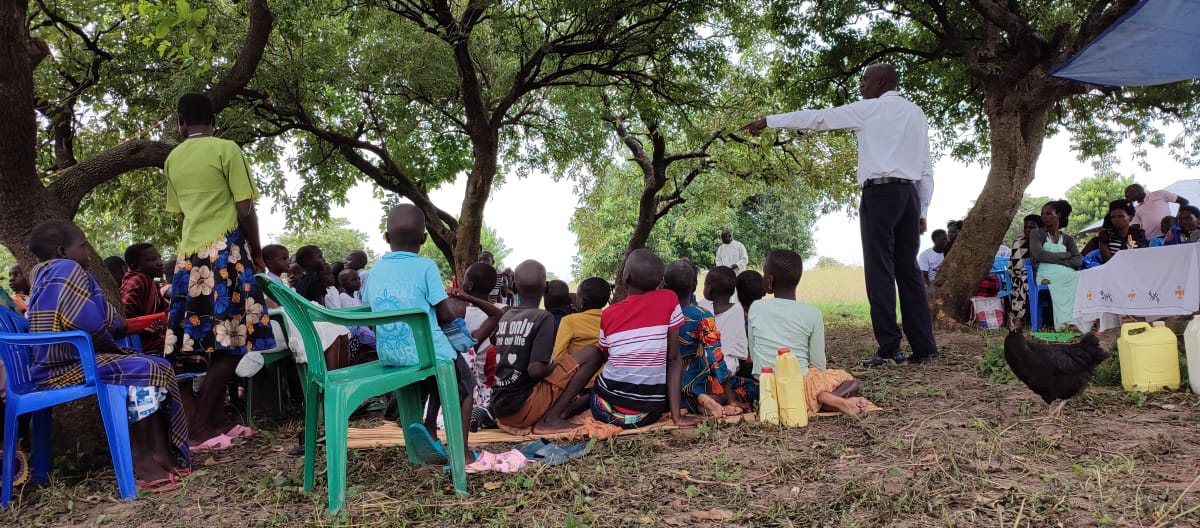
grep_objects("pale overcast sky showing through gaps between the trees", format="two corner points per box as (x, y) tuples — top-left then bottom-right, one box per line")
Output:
(259, 126), (1200, 278)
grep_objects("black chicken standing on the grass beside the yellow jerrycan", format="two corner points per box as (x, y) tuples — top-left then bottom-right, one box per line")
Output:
(1004, 329), (1109, 416)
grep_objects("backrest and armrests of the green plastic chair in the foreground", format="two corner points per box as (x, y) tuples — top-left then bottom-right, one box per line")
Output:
(256, 274), (437, 379)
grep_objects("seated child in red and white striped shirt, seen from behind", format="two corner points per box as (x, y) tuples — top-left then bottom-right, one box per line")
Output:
(592, 248), (703, 428)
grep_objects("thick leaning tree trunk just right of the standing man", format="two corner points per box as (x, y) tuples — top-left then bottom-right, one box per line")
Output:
(930, 97), (1052, 324)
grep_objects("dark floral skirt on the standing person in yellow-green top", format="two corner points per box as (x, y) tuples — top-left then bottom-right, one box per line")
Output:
(163, 229), (275, 373)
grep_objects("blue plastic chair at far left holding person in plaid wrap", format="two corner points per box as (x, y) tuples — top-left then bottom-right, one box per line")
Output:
(0, 308), (137, 508)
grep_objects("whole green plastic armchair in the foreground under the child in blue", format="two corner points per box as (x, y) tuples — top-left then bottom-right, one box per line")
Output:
(256, 274), (467, 512)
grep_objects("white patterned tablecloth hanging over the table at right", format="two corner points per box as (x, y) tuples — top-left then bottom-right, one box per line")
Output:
(1075, 244), (1200, 330)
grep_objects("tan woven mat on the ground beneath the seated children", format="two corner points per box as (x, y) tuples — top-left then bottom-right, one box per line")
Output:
(347, 404), (883, 449)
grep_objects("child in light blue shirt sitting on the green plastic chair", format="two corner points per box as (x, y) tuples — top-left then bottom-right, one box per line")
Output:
(362, 204), (505, 473)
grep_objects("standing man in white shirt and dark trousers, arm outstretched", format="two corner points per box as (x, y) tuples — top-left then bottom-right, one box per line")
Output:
(743, 64), (937, 366)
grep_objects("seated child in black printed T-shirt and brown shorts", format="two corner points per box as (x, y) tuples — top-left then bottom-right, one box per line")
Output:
(492, 260), (604, 434)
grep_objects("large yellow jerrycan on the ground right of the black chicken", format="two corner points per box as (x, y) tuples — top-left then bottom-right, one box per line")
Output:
(1117, 322), (1180, 392)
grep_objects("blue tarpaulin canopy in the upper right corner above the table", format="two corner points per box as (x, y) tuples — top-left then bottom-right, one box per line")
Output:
(1050, 0), (1200, 86)
